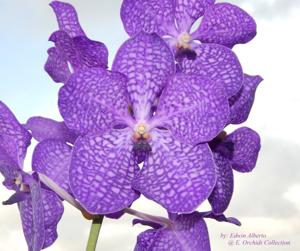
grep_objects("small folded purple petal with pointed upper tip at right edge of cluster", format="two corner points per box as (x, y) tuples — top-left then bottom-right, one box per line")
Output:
(229, 74), (263, 124)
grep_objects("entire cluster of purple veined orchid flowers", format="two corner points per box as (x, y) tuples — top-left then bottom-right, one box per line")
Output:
(0, 0), (262, 251)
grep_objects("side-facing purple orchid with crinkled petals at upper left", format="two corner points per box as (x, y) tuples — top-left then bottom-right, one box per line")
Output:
(45, 1), (108, 83)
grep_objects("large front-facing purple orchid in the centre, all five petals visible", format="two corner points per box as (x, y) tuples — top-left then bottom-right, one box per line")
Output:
(54, 27), (229, 214)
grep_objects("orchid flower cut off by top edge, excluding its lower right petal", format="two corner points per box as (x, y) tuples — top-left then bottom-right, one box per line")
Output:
(121, 0), (256, 59)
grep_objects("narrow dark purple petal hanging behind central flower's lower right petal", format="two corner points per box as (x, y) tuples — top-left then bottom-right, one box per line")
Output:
(208, 153), (233, 214)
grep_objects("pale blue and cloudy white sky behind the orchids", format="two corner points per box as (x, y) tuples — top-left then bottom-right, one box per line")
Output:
(0, 0), (300, 251)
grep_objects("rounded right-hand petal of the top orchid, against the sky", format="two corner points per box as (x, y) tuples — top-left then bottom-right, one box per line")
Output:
(193, 3), (256, 48)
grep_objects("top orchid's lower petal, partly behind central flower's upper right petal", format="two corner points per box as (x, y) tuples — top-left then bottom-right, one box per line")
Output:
(182, 44), (243, 98)
